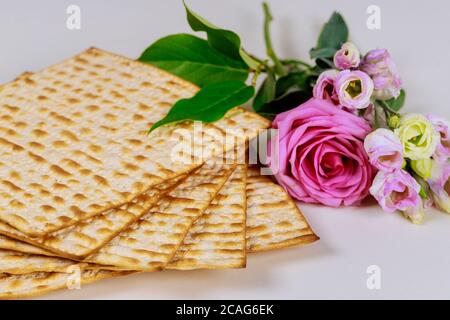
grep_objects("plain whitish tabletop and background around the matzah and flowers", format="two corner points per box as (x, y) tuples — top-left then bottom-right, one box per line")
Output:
(0, 0), (450, 299)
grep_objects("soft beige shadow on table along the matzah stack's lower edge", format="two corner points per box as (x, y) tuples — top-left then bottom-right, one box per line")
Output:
(44, 240), (331, 300)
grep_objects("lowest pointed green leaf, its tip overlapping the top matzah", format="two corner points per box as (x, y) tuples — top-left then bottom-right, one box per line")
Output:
(150, 81), (255, 132)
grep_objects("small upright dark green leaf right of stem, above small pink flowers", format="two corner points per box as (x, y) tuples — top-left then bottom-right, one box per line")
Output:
(309, 12), (348, 59)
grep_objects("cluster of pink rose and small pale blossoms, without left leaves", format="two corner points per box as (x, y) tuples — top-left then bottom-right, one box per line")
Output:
(273, 19), (450, 224)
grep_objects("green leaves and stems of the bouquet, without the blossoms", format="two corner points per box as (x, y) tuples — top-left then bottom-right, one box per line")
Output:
(139, 2), (404, 131)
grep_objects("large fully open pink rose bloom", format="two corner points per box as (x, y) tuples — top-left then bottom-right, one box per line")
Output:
(269, 98), (375, 207)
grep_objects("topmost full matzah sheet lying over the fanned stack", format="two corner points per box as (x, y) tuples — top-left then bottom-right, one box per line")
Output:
(0, 49), (269, 236)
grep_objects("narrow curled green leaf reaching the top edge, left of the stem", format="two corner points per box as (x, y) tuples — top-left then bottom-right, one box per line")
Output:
(183, 1), (259, 69)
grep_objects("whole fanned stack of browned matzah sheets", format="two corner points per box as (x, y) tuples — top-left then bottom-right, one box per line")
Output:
(0, 49), (318, 298)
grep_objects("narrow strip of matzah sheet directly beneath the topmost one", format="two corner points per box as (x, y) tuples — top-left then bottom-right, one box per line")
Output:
(0, 175), (186, 259)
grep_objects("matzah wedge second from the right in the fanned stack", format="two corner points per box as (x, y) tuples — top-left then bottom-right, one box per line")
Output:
(166, 164), (247, 270)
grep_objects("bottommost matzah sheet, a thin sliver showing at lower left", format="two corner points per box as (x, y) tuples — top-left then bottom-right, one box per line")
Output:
(0, 269), (130, 299)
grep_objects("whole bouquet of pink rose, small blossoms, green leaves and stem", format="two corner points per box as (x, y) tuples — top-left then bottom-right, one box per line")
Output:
(139, 3), (450, 223)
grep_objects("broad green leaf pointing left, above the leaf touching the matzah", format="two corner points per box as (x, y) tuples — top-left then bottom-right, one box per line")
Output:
(139, 34), (249, 87)
